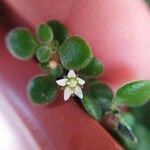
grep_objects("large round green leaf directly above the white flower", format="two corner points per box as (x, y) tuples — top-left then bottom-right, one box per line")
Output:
(59, 36), (93, 70)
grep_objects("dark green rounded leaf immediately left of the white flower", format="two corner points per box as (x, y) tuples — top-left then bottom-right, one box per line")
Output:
(28, 75), (57, 104)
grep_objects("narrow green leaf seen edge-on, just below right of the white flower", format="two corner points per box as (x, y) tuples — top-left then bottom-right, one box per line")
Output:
(81, 96), (102, 121)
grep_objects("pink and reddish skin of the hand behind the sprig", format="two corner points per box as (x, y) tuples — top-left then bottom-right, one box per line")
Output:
(0, 0), (150, 150)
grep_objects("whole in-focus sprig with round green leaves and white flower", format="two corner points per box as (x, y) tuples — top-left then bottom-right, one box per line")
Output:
(6, 20), (150, 146)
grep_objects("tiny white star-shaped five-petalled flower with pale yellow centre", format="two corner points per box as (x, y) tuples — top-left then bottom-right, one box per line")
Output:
(56, 70), (85, 101)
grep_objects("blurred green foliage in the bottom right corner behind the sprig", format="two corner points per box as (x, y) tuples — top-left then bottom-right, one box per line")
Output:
(125, 103), (150, 150)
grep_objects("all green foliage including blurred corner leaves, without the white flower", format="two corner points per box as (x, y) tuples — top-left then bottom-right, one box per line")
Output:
(7, 20), (150, 150)
